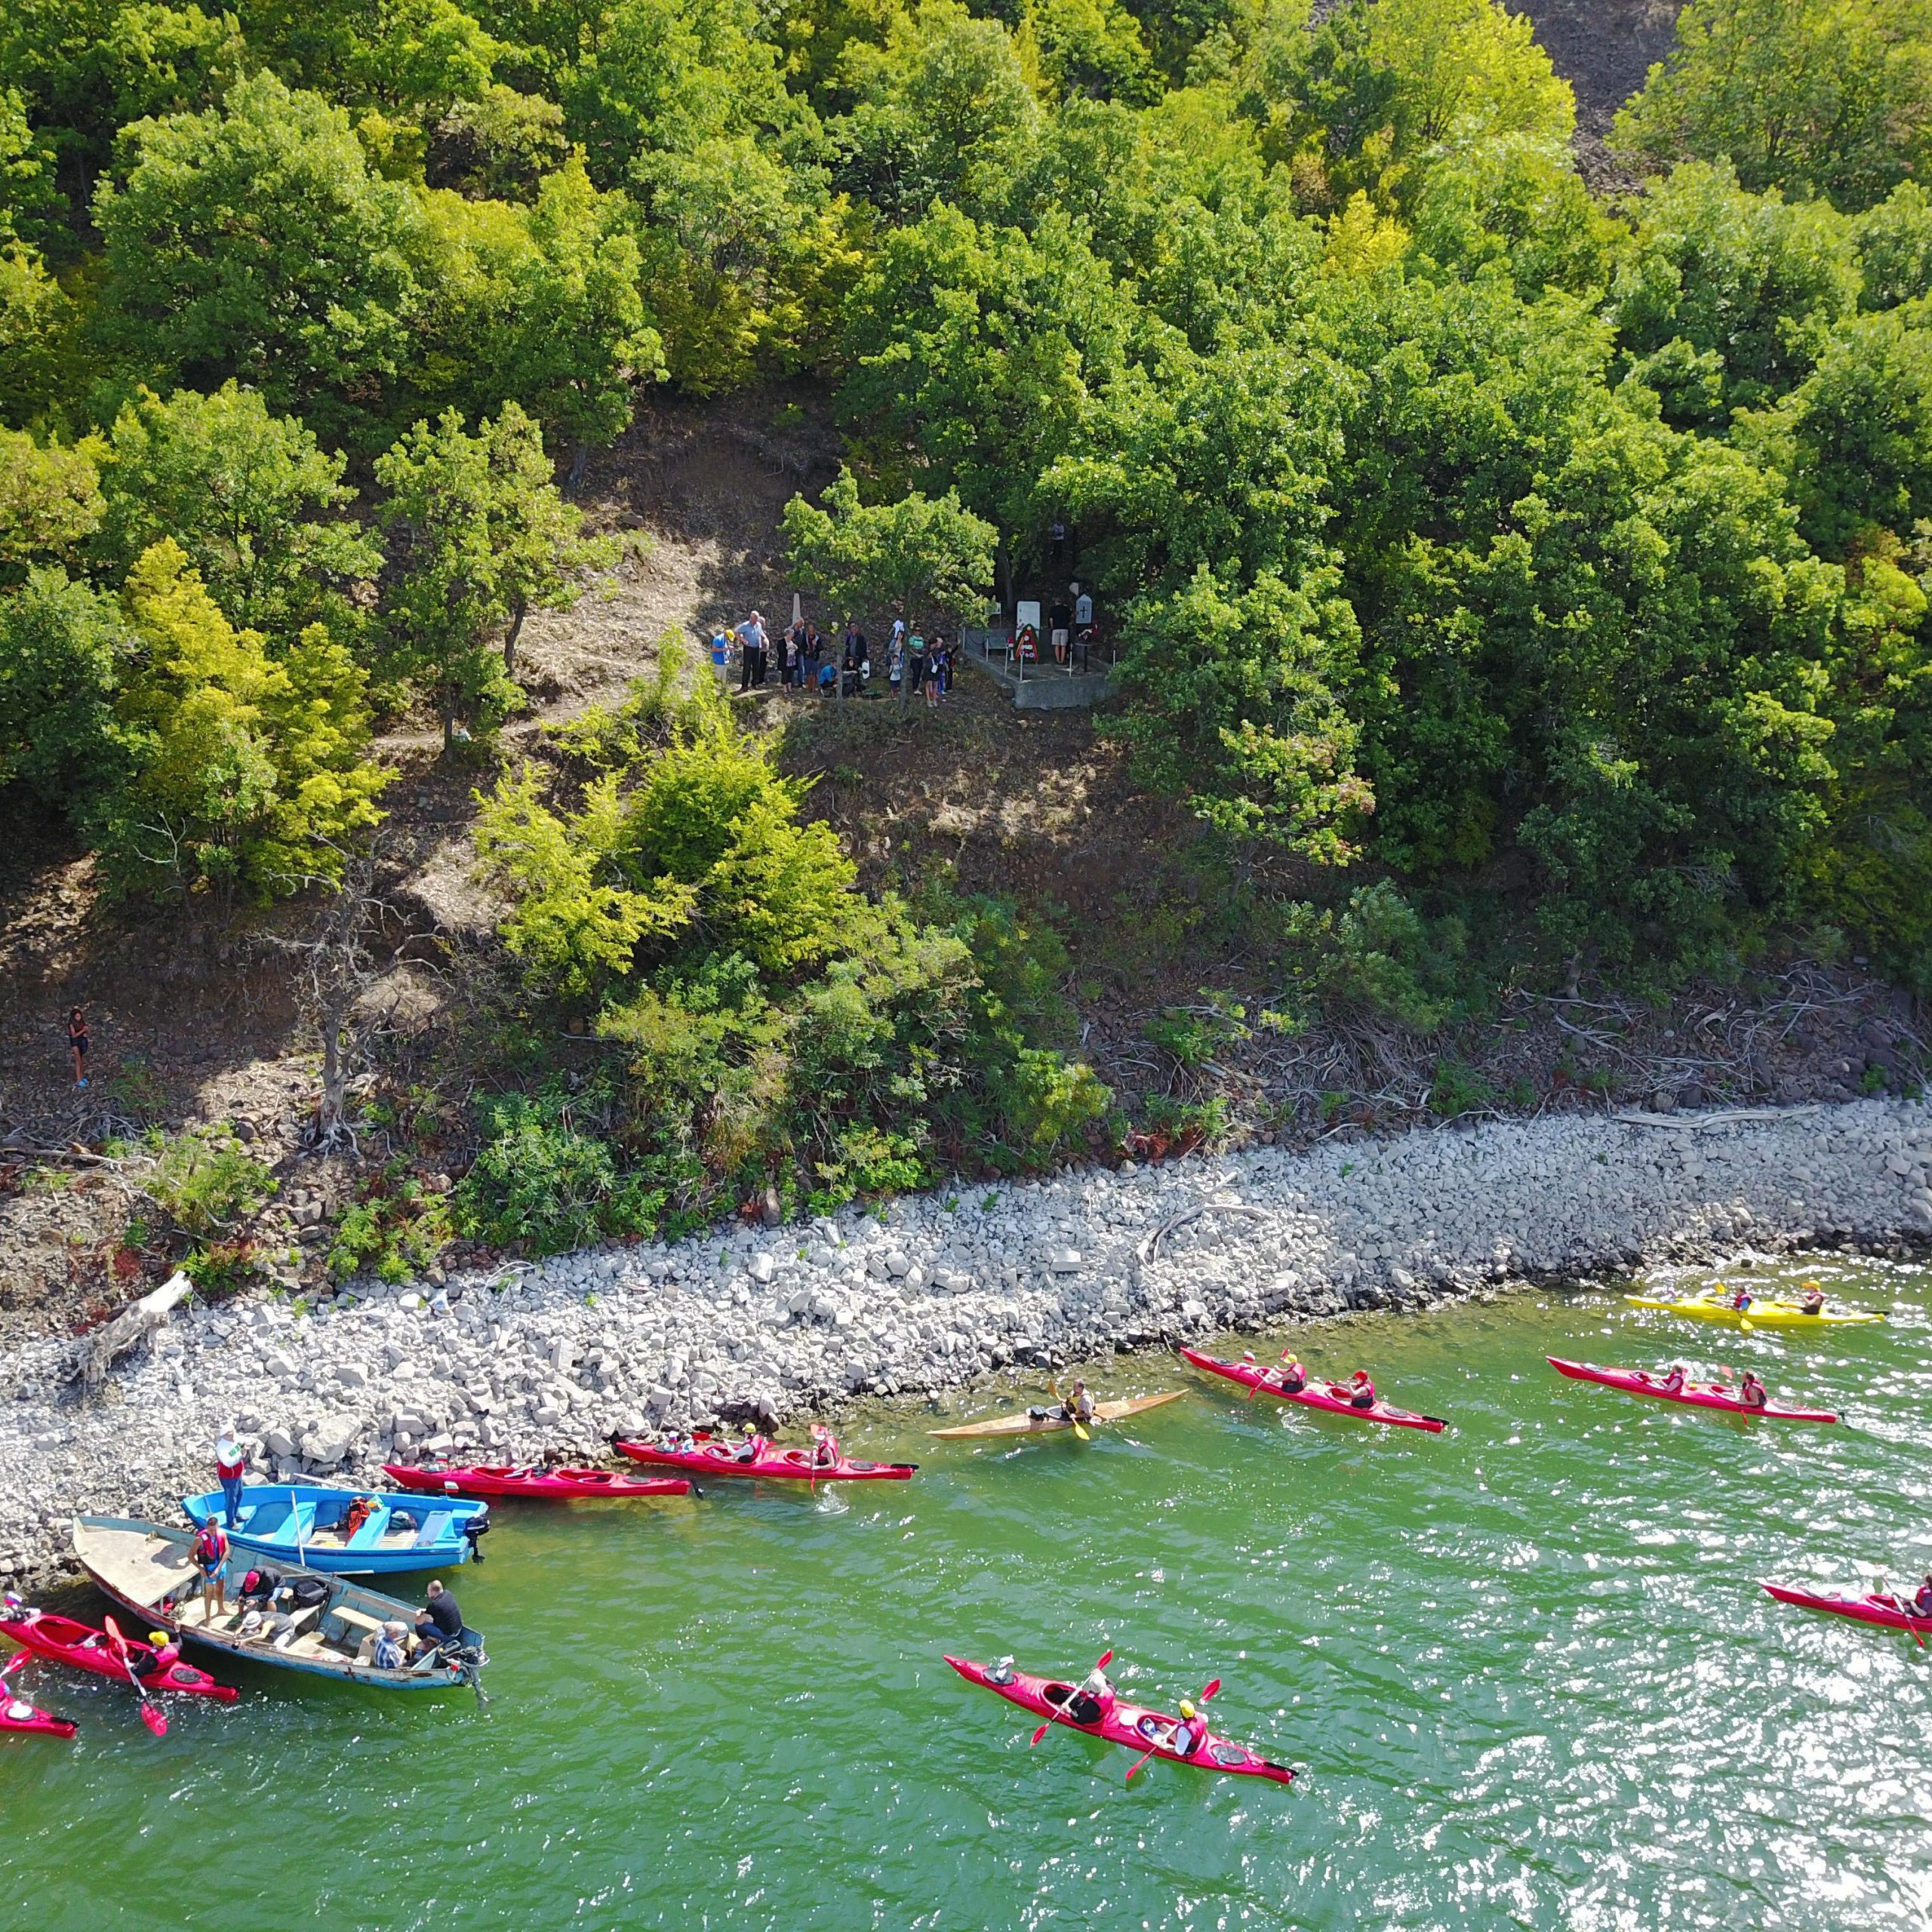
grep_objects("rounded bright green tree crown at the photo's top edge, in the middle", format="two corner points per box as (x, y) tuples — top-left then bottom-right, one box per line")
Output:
(829, 0), (1041, 222)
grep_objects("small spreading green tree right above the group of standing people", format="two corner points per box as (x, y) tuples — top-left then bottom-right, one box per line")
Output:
(784, 469), (997, 637)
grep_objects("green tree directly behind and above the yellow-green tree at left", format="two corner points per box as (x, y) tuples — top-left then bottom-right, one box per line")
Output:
(97, 380), (383, 639)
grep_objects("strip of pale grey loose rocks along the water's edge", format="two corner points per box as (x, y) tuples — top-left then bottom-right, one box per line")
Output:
(0, 1100), (1932, 1584)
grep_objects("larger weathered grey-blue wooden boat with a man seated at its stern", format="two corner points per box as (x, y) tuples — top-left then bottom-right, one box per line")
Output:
(73, 1517), (489, 1702)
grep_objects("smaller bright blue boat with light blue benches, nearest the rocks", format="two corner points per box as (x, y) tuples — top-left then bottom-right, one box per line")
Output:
(182, 1482), (489, 1577)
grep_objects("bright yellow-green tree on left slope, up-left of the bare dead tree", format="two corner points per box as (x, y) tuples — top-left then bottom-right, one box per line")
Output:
(100, 539), (389, 898)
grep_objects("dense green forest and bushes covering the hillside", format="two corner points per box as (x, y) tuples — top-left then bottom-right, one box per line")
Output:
(0, 0), (1932, 1238)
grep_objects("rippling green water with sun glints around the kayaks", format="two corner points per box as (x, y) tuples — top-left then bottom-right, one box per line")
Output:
(0, 1262), (1932, 1932)
